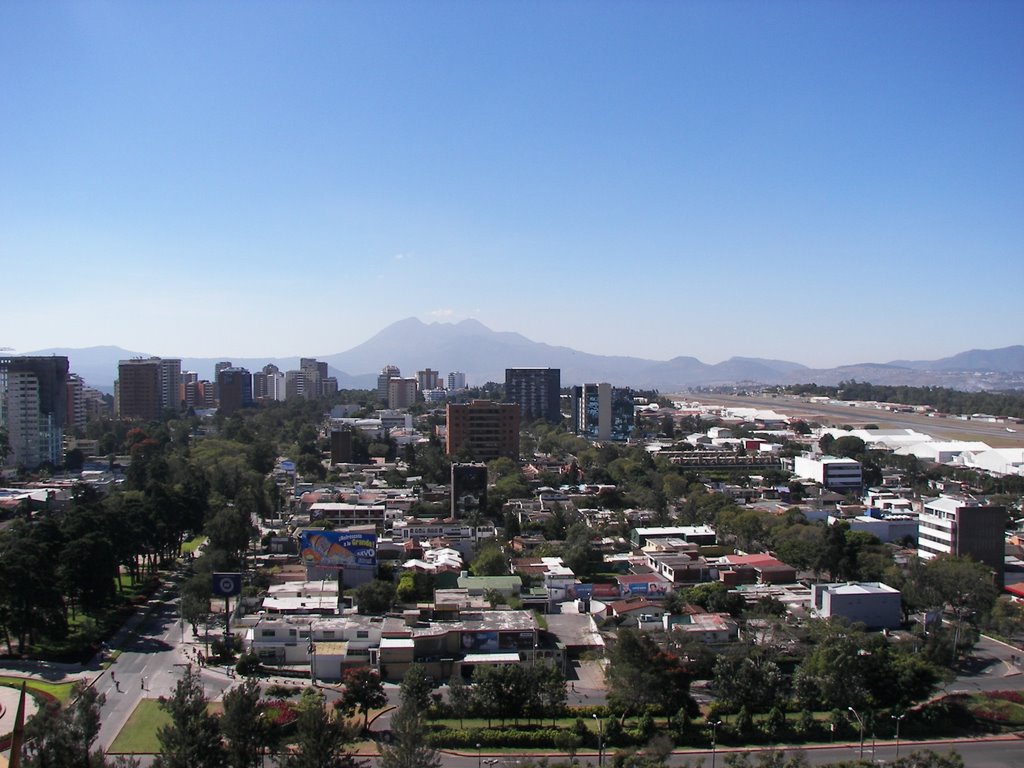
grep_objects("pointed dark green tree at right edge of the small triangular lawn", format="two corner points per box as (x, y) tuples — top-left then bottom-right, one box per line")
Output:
(154, 668), (227, 768)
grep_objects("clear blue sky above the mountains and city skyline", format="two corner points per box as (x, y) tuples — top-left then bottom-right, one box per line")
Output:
(0, 0), (1024, 366)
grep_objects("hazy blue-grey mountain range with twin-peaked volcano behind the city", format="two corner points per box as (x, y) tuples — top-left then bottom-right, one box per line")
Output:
(16, 317), (1024, 392)
